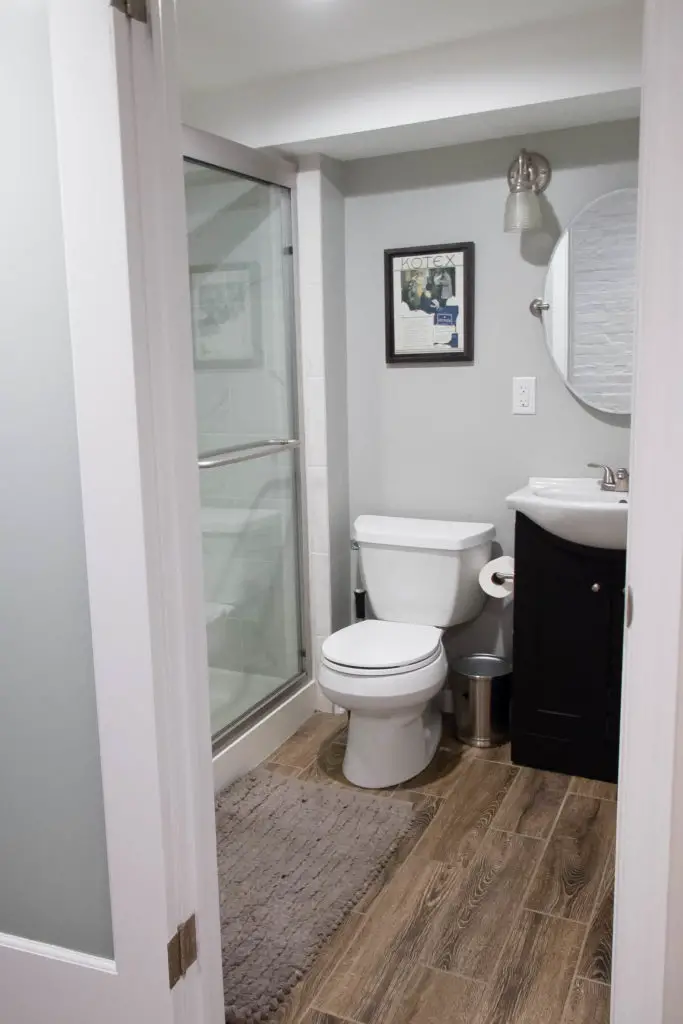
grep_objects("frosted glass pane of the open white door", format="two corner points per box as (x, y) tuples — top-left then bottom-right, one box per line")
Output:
(0, 2), (114, 958)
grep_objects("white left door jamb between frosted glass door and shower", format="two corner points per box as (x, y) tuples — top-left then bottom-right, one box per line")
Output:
(115, 0), (225, 1024)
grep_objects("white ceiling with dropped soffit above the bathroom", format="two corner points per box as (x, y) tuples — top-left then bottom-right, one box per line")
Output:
(176, 0), (643, 160)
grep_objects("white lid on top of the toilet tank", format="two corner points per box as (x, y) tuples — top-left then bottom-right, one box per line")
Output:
(353, 515), (496, 551)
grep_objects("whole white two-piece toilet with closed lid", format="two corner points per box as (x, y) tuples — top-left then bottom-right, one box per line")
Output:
(318, 515), (496, 790)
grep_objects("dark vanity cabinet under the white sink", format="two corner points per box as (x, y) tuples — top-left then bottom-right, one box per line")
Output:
(511, 513), (626, 782)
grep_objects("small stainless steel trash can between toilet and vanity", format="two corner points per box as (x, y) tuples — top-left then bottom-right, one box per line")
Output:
(452, 654), (512, 746)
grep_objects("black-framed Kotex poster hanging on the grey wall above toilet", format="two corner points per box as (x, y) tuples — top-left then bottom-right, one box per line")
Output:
(384, 242), (474, 364)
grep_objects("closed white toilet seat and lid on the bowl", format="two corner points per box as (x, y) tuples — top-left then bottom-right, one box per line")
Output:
(322, 620), (441, 676)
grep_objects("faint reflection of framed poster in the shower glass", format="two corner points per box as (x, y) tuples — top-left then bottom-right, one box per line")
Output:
(189, 263), (263, 370)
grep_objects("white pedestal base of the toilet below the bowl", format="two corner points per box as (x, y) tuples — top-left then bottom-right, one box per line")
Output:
(342, 700), (441, 790)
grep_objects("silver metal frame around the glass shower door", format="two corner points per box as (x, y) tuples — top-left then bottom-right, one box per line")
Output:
(182, 125), (312, 757)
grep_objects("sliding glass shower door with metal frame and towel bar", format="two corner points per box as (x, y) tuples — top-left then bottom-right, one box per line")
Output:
(184, 129), (305, 750)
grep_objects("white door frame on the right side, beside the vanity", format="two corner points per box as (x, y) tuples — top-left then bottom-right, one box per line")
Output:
(611, 0), (683, 1024)
